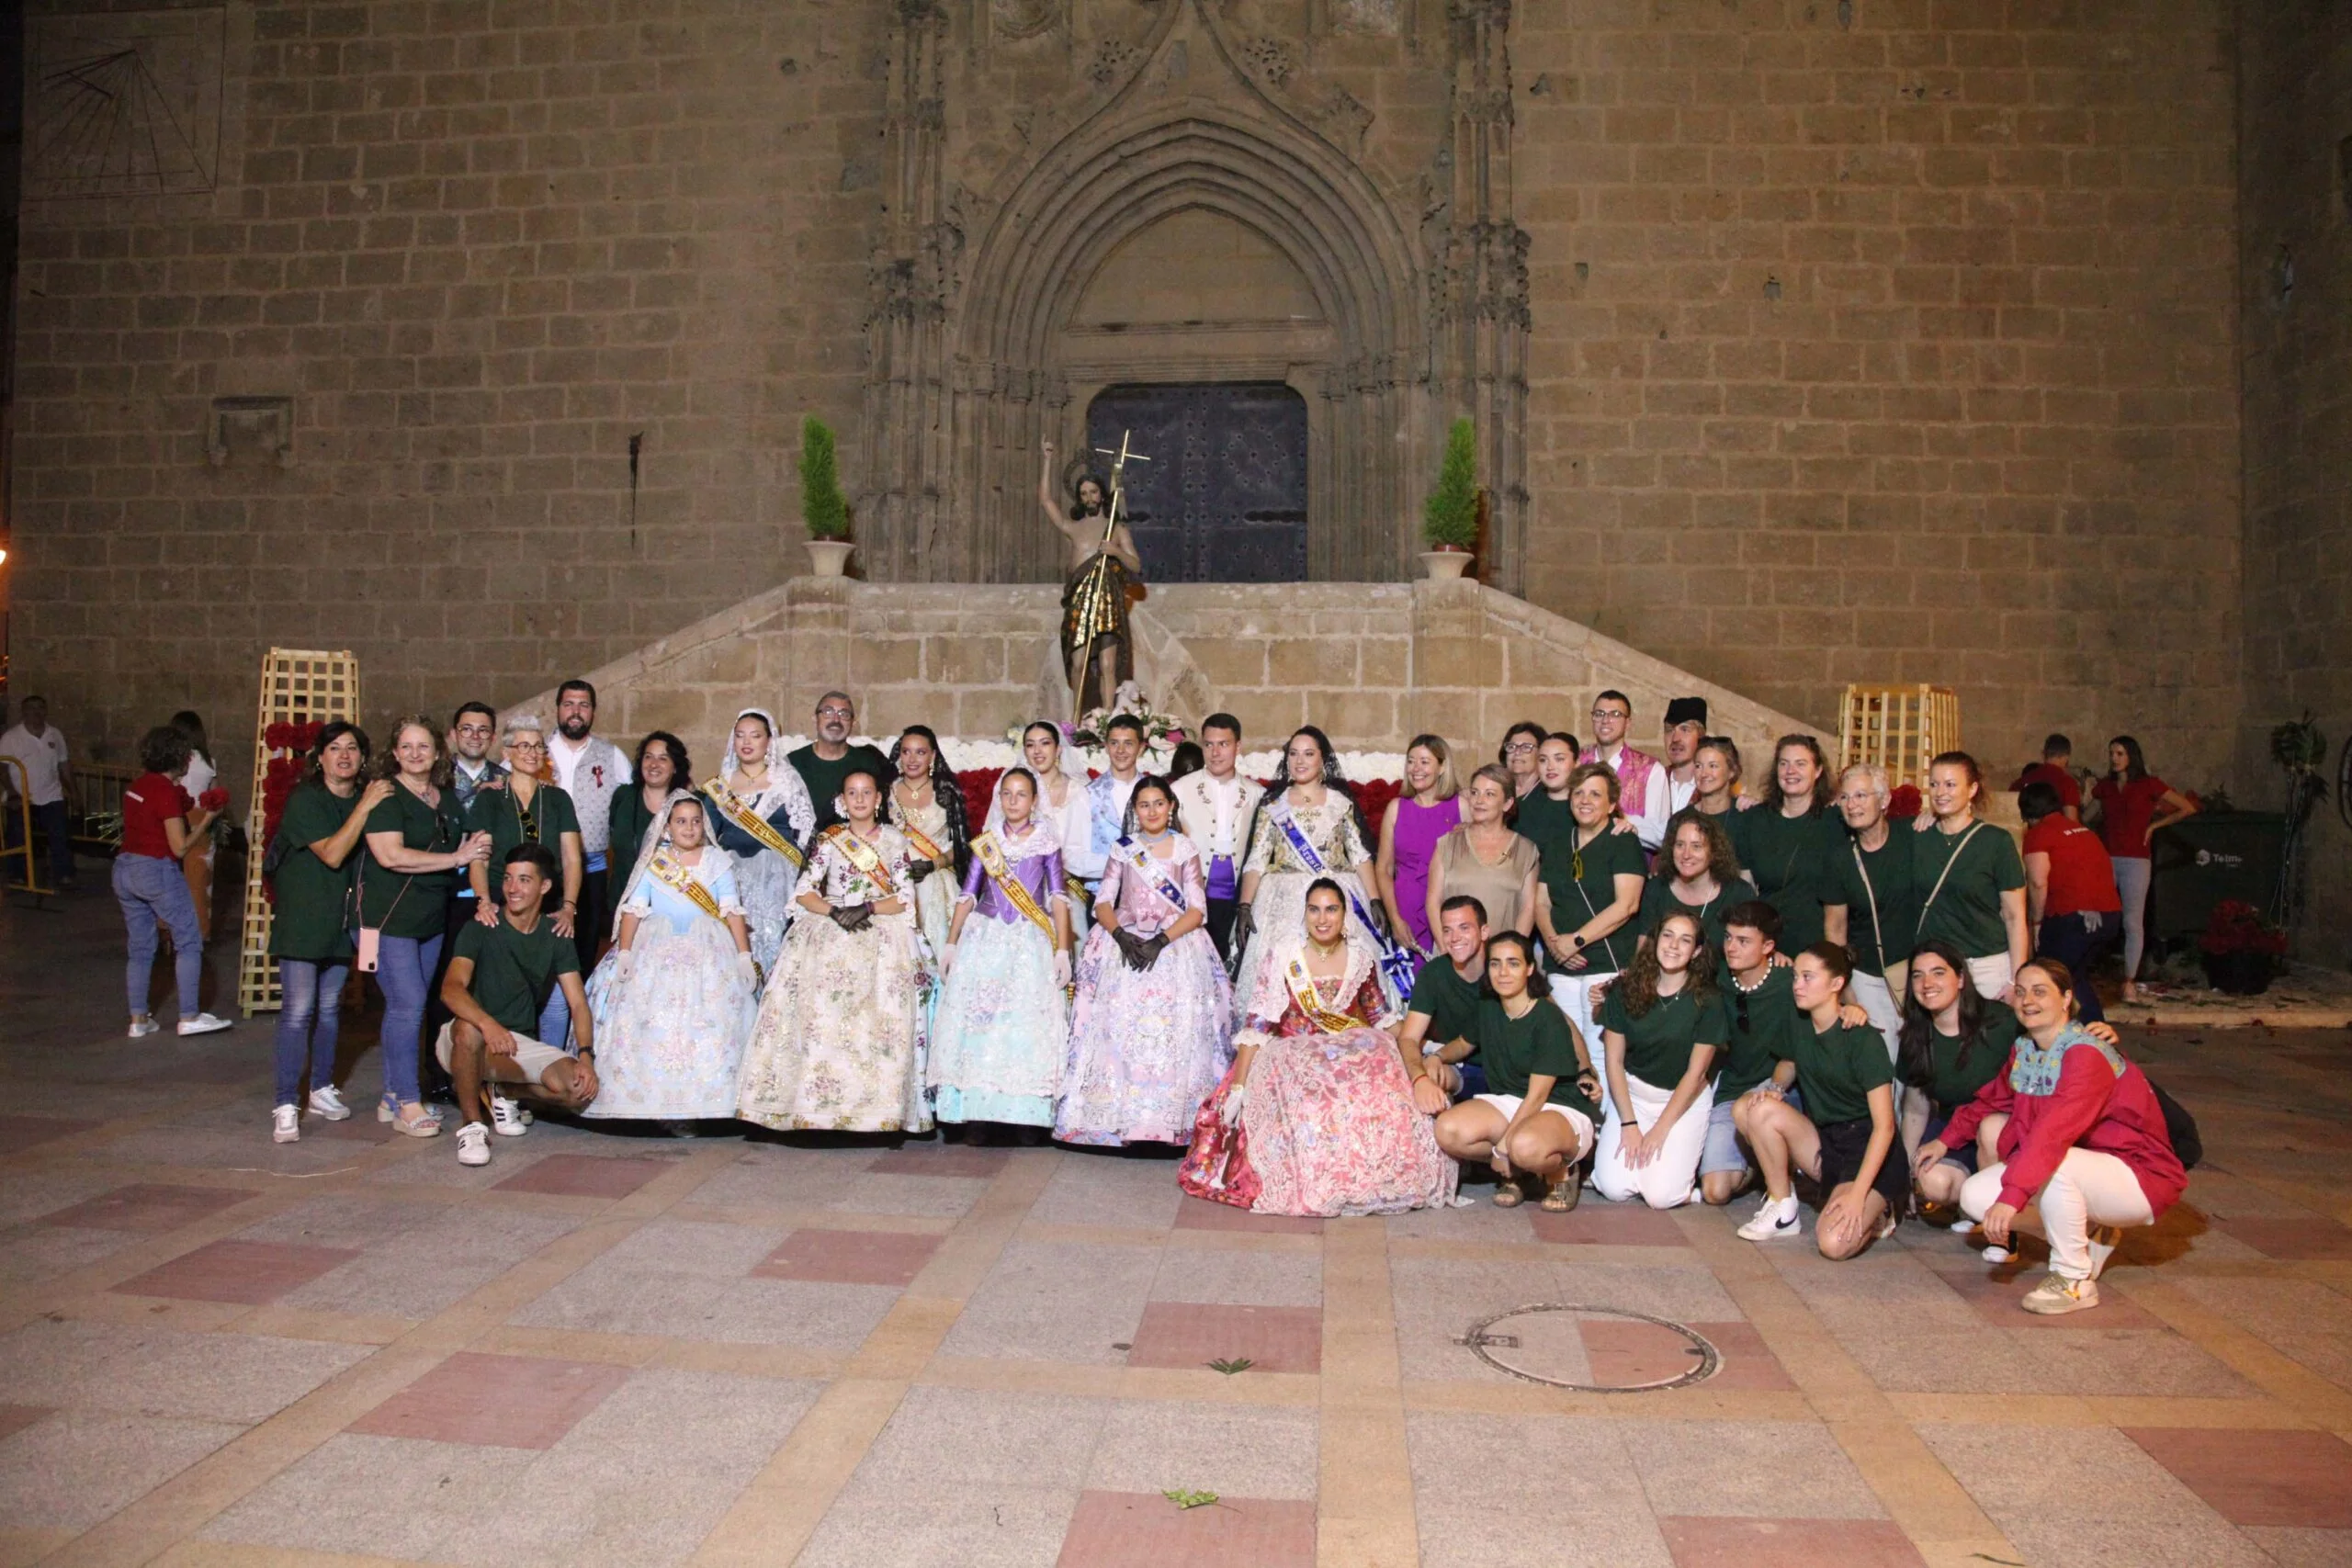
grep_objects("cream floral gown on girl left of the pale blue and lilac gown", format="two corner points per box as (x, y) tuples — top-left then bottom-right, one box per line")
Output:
(736, 825), (932, 1134)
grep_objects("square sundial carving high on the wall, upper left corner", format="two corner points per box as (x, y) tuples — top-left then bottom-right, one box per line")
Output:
(26, 7), (223, 200)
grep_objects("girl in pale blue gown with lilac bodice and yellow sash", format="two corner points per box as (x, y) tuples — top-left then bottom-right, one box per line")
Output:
(929, 766), (1070, 1128)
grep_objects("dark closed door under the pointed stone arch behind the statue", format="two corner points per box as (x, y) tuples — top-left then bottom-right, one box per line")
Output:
(1087, 381), (1307, 583)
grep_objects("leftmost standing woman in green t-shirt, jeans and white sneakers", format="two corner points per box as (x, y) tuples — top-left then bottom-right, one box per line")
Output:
(270, 719), (393, 1143)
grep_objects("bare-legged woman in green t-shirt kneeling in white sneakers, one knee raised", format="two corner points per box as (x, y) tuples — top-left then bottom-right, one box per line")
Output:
(1731, 942), (1910, 1260)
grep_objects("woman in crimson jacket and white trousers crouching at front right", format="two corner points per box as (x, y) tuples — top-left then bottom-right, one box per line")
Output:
(1919, 959), (2189, 1316)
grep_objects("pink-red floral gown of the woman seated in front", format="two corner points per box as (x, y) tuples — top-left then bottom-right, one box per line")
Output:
(1194, 945), (1458, 1215)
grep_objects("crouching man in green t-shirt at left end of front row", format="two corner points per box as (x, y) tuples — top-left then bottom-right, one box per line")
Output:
(433, 844), (597, 1166)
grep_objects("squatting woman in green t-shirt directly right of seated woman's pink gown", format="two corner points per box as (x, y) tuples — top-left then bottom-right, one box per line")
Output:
(1437, 931), (1600, 1213)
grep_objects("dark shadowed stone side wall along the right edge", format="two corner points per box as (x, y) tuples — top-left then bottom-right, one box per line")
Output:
(2237, 0), (2352, 966)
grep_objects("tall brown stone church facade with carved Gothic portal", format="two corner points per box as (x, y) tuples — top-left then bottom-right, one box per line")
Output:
(12, 0), (2352, 959)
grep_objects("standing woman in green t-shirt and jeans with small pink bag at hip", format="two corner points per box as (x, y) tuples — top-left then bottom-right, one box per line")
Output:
(360, 715), (489, 1138)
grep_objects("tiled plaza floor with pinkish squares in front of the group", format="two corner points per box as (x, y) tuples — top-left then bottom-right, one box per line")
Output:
(0, 888), (2352, 1568)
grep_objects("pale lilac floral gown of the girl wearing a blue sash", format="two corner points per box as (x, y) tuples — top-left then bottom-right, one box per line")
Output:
(1054, 832), (1232, 1145)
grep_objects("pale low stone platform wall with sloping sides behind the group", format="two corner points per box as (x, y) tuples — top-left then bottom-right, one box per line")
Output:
(508, 579), (1806, 778)
